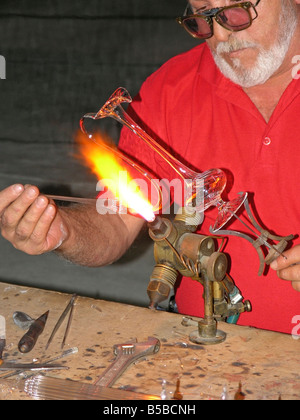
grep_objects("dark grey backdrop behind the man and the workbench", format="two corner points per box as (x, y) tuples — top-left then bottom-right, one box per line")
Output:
(0, 0), (197, 305)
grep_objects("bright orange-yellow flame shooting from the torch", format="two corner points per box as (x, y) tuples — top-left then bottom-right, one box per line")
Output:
(76, 132), (155, 222)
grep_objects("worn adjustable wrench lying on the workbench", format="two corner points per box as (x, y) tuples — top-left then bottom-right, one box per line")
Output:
(94, 337), (160, 387)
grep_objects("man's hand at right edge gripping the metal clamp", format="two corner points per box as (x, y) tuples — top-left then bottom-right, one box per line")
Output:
(270, 245), (300, 292)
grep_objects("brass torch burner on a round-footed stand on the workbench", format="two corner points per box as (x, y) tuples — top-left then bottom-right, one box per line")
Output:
(147, 208), (251, 344)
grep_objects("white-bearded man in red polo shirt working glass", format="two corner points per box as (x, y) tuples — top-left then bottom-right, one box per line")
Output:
(0, 0), (300, 333)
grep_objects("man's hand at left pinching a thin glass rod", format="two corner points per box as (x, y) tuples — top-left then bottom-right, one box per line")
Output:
(0, 184), (68, 255)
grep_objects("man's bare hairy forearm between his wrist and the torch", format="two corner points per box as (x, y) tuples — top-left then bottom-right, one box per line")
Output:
(55, 206), (143, 267)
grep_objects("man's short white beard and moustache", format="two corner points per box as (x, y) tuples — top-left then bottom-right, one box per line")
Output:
(212, 2), (297, 88)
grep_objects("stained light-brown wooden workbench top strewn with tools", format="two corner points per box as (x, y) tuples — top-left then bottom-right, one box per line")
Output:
(0, 283), (300, 400)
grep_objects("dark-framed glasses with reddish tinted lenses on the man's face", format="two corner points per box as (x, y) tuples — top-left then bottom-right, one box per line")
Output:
(176, 0), (260, 39)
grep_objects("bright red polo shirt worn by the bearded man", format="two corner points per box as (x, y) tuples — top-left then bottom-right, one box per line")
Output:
(119, 44), (300, 333)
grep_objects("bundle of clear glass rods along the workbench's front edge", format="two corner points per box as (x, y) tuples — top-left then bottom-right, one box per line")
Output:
(22, 376), (160, 401)
